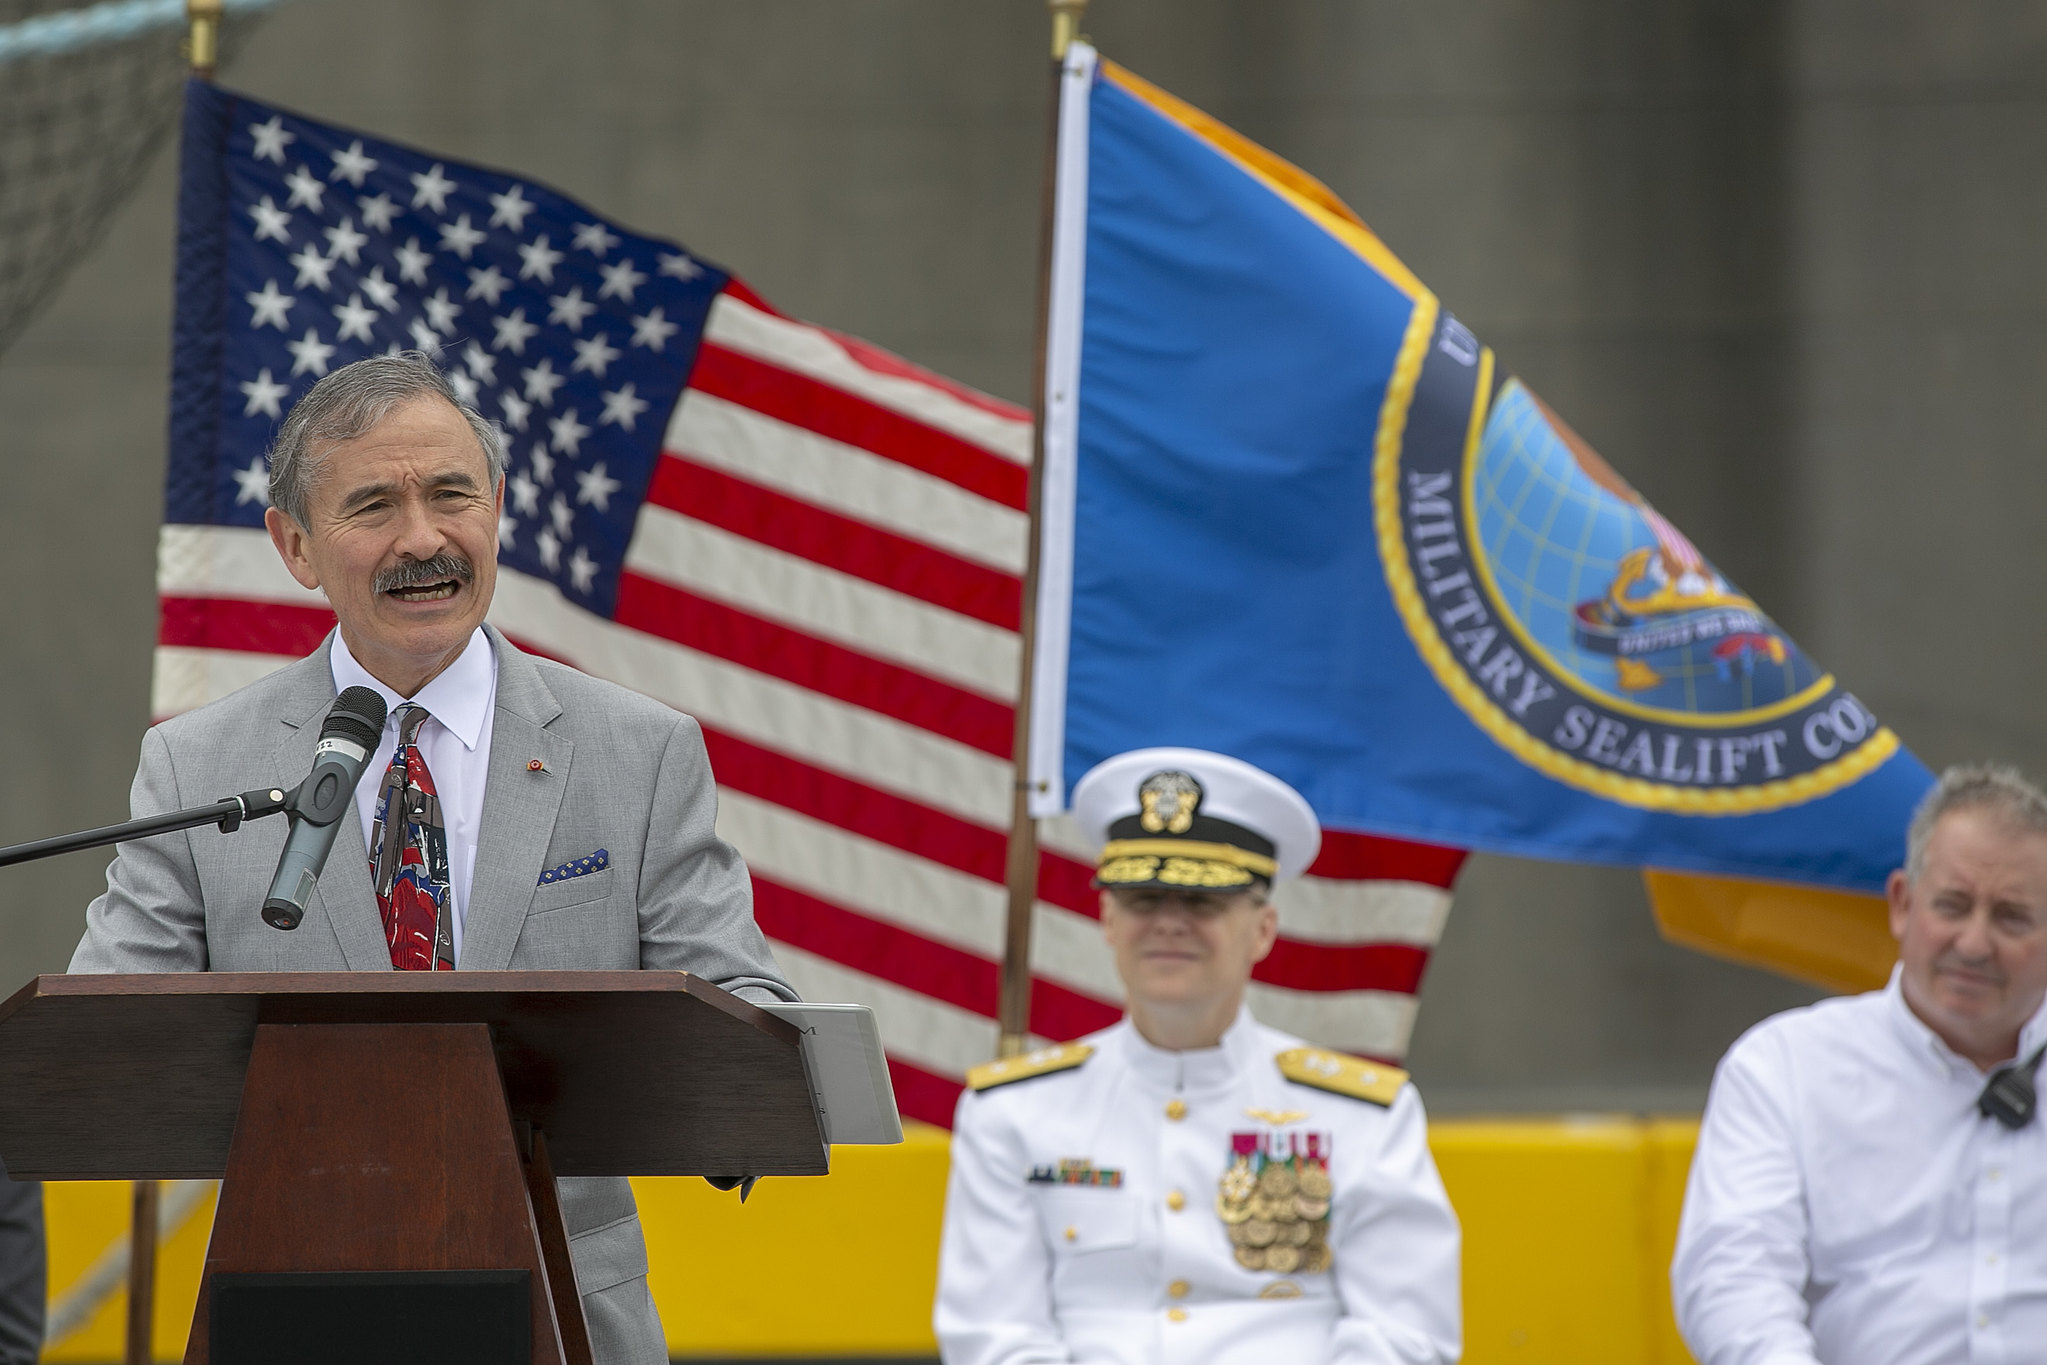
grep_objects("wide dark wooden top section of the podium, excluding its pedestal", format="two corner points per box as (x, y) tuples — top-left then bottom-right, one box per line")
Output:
(0, 972), (827, 1179)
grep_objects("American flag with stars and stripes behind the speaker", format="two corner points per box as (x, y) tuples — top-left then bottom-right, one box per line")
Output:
(154, 84), (1464, 1124)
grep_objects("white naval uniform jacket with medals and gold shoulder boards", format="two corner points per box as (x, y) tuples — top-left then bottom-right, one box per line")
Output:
(935, 1013), (1462, 1365)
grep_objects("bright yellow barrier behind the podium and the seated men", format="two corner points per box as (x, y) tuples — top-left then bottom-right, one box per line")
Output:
(45, 1117), (1697, 1365)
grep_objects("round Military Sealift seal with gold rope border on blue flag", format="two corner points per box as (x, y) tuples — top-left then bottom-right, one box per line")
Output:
(1374, 295), (1898, 814)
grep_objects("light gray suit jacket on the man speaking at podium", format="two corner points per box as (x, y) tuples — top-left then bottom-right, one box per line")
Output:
(72, 630), (796, 1365)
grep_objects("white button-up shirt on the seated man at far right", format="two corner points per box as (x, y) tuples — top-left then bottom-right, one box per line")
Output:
(1670, 972), (2047, 1365)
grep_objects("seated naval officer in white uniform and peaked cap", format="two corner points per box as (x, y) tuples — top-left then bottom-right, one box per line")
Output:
(935, 749), (1462, 1365)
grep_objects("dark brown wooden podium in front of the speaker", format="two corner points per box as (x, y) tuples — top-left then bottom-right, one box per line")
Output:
(0, 972), (829, 1365)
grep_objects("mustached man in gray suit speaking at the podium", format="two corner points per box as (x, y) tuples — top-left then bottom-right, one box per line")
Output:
(72, 352), (796, 1365)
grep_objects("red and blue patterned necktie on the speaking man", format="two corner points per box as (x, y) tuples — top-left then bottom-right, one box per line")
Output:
(371, 702), (454, 972)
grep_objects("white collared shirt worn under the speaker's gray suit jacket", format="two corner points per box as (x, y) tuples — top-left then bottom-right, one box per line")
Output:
(330, 626), (497, 964)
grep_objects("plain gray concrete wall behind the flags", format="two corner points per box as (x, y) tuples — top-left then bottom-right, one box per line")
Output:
(0, 0), (2047, 1109)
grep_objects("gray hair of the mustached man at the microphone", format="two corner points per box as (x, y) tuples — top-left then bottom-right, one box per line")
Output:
(270, 350), (506, 526)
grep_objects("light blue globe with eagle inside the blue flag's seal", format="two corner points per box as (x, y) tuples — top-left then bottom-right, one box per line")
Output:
(1468, 381), (1826, 722)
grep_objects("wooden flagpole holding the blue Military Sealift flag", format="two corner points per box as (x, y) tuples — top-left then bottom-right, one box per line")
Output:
(995, 0), (1087, 1056)
